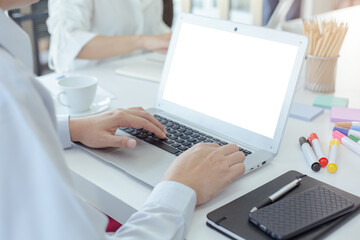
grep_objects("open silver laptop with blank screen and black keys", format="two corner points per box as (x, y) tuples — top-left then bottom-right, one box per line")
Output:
(80, 14), (308, 186)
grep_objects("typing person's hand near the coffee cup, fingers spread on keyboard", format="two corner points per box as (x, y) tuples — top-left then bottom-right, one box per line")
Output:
(69, 107), (166, 148)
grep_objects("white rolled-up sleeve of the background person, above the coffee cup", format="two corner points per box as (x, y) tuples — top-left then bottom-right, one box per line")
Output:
(47, 0), (96, 72)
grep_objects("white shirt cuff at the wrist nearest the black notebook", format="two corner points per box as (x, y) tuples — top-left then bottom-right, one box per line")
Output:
(145, 181), (196, 232)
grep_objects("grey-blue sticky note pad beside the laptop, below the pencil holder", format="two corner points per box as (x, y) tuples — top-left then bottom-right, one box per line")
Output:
(290, 103), (324, 121)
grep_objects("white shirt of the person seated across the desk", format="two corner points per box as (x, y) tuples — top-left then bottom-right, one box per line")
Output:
(47, 0), (170, 72)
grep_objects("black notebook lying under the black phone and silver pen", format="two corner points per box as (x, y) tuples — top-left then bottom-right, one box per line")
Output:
(207, 171), (360, 240)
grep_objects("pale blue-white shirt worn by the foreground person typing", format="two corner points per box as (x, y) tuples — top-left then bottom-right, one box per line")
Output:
(0, 9), (196, 240)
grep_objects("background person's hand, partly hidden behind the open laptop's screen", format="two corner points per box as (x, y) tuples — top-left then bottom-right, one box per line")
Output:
(144, 33), (171, 54)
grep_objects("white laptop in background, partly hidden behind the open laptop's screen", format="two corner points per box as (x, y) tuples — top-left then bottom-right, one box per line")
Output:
(115, 52), (166, 82)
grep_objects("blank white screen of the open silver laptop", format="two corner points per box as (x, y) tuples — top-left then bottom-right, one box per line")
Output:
(163, 23), (298, 138)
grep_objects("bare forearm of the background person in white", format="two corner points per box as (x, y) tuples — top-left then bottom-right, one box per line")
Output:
(77, 35), (146, 59)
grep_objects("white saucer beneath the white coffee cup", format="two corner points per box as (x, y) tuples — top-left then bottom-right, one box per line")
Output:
(56, 95), (111, 118)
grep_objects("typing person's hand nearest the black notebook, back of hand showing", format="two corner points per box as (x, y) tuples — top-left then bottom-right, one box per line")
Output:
(162, 143), (245, 205)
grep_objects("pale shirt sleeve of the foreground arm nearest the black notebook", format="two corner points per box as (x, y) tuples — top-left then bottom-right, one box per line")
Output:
(108, 181), (196, 240)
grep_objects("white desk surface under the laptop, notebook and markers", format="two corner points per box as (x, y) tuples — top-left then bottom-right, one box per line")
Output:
(40, 7), (360, 240)
